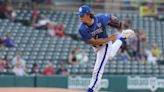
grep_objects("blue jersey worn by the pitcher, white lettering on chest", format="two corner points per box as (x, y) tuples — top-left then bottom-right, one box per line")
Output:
(79, 14), (111, 42)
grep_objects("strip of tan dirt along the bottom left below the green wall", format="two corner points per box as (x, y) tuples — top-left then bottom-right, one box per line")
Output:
(0, 88), (84, 92)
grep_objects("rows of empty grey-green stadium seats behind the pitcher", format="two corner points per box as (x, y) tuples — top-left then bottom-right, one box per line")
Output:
(0, 10), (164, 75)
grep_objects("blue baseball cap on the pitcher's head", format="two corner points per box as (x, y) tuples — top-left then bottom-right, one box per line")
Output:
(78, 5), (92, 16)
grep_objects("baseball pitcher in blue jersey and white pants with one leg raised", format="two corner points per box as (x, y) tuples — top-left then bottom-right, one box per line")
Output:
(78, 5), (134, 92)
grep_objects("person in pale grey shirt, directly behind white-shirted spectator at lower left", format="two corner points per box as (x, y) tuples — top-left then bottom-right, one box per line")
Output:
(12, 52), (26, 69)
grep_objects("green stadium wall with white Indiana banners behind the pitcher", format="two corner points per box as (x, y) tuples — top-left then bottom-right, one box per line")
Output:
(0, 75), (164, 92)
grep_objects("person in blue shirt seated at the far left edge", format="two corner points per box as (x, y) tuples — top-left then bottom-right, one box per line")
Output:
(2, 34), (16, 48)
